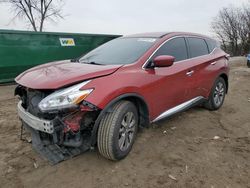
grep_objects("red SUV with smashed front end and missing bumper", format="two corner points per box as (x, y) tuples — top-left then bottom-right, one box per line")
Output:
(15, 32), (229, 163)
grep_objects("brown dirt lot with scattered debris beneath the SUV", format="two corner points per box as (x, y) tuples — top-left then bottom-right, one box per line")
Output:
(0, 58), (250, 188)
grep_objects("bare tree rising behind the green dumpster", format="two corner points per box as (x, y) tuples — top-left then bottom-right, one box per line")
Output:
(0, 0), (64, 31)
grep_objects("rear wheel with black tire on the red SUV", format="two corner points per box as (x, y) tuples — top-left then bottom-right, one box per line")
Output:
(204, 77), (227, 110)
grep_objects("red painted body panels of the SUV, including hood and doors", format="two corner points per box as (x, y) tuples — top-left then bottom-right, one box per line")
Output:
(16, 33), (229, 120)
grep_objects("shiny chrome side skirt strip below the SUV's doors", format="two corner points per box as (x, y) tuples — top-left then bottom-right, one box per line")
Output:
(152, 96), (205, 123)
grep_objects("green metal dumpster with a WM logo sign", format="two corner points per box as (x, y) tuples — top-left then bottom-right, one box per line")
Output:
(0, 30), (119, 83)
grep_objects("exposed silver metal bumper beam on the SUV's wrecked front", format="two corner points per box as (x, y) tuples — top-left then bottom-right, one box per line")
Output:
(17, 101), (54, 134)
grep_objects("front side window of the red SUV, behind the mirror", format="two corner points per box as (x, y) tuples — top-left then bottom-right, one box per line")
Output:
(153, 37), (188, 61)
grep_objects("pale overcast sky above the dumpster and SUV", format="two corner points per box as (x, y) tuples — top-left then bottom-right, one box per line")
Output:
(0, 0), (247, 35)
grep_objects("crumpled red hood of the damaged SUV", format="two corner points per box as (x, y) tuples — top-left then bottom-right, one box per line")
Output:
(15, 60), (122, 89)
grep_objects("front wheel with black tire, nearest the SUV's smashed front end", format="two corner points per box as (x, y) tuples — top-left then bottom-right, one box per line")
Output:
(97, 101), (138, 160)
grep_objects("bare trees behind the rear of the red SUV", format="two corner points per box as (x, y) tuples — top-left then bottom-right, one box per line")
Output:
(211, 4), (250, 55)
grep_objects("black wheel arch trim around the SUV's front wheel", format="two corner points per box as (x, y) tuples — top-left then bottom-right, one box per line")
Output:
(91, 93), (149, 148)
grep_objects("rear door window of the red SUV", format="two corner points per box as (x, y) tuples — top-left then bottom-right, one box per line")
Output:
(188, 37), (209, 58)
